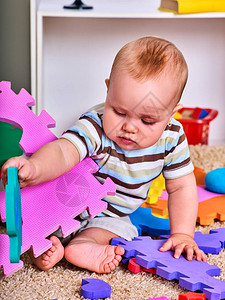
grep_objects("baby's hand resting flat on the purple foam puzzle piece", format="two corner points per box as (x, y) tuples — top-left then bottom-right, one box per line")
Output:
(159, 233), (206, 261)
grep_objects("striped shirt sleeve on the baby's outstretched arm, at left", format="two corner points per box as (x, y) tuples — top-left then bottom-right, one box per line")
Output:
(61, 111), (102, 161)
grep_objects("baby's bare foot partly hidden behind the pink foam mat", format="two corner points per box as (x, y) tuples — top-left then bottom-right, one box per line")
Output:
(28, 236), (64, 271)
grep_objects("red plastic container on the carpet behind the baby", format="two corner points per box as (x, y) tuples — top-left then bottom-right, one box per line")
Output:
(178, 107), (218, 145)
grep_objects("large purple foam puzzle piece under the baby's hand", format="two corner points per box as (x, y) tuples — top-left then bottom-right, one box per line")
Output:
(112, 236), (225, 300)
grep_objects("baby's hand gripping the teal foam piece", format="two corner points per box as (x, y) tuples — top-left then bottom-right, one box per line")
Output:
(1, 157), (35, 188)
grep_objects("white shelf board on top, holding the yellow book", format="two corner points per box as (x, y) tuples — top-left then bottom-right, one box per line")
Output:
(38, 0), (225, 19)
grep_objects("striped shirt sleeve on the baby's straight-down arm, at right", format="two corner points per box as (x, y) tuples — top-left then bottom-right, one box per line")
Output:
(163, 120), (194, 179)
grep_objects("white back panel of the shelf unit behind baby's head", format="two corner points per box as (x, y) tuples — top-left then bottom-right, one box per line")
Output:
(40, 17), (225, 143)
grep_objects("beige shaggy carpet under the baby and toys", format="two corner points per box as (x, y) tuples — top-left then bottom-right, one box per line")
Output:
(0, 146), (225, 300)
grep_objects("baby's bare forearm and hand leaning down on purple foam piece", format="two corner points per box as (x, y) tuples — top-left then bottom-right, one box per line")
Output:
(160, 173), (206, 261)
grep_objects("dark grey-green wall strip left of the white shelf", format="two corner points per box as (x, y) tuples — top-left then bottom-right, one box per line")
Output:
(0, 0), (31, 93)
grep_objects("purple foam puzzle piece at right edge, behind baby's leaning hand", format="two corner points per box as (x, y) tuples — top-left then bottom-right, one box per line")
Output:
(160, 228), (225, 254)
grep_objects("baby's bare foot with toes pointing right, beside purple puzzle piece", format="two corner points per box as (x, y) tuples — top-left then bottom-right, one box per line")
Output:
(65, 241), (124, 273)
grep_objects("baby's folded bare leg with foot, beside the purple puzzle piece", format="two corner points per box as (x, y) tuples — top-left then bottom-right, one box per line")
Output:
(64, 227), (124, 273)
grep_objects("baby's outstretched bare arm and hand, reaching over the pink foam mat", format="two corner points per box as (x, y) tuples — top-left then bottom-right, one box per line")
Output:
(1, 138), (80, 188)
